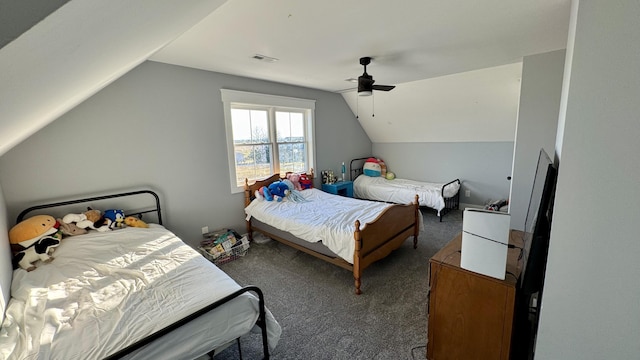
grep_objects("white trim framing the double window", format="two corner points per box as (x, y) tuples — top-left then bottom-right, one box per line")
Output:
(220, 89), (316, 194)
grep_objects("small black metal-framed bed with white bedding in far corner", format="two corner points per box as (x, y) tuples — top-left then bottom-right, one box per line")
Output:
(349, 157), (460, 222)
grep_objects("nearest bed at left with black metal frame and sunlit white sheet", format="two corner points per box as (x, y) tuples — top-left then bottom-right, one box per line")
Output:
(0, 190), (281, 360)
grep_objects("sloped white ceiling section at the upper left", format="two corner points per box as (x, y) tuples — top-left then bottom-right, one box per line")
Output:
(0, 0), (229, 155)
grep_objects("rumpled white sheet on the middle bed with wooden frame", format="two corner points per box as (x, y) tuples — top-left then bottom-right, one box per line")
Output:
(245, 189), (422, 264)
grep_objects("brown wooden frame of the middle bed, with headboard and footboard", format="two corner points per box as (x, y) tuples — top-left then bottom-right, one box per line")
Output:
(244, 174), (420, 295)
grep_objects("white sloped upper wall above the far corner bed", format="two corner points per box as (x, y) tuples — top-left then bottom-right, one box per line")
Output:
(342, 62), (522, 143)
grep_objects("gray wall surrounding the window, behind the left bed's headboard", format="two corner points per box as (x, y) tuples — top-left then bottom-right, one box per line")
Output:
(0, 62), (371, 245)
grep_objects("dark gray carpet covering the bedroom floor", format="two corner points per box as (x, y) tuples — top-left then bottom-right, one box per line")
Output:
(214, 209), (462, 360)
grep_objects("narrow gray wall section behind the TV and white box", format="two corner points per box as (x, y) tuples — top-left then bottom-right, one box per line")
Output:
(509, 50), (565, 230)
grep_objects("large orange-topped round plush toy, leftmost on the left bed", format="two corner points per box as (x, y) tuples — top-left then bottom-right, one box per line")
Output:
(9, 215), (62, 271)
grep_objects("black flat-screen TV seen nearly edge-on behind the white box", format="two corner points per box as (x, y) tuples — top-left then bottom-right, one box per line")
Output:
(520, 149), (557, 295)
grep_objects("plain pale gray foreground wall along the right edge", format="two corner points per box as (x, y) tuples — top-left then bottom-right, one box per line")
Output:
(536, 0), (640, 360)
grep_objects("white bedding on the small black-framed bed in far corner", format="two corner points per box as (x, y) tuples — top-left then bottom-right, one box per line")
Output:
(353, 175), (460, 215)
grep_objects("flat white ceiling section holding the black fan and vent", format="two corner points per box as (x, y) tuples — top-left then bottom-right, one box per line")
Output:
(150, 0), (571, 92)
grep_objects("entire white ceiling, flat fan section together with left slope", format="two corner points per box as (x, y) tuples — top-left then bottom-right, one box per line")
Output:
(0, 0), (570, 155)
